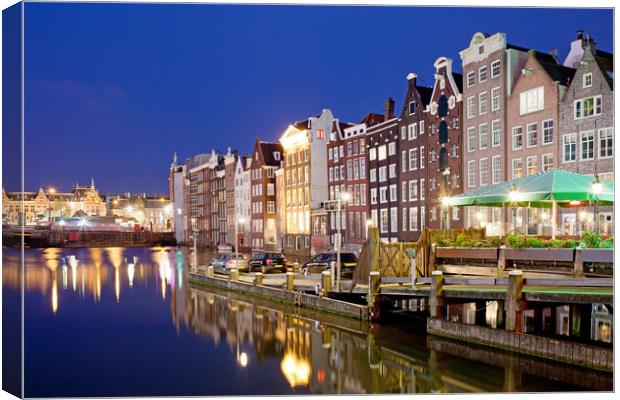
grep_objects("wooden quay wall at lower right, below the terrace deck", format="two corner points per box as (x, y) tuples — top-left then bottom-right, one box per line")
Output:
(426, 318), (614, 371)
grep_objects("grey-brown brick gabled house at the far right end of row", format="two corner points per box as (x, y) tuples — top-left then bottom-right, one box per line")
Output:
(559, 38), (614, 234)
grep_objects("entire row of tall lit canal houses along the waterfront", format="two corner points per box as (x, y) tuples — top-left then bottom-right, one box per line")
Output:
(170, 31), (614, 257)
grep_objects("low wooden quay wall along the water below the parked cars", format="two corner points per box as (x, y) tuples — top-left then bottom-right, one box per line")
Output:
(189, 272), (368, 320)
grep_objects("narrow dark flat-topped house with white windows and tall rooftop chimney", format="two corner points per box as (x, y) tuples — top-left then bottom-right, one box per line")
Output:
(366, 97), (400, 242)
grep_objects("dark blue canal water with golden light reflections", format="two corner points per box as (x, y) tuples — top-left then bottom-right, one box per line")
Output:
(2, 248), (612, 397)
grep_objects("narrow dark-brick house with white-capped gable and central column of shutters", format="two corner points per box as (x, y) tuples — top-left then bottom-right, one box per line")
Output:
(426, 57), (463, 229)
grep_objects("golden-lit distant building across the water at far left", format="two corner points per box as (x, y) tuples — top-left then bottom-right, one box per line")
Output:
(2, 179), (106, 224)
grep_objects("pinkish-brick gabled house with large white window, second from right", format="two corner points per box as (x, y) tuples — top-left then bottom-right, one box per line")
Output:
(506, 50), (575, 234)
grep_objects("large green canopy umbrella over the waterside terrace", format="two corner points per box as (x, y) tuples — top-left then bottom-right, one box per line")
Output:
(445, 169), (614, 208)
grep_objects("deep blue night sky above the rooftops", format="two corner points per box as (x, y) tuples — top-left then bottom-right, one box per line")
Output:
(3, 3), (613, 193)
